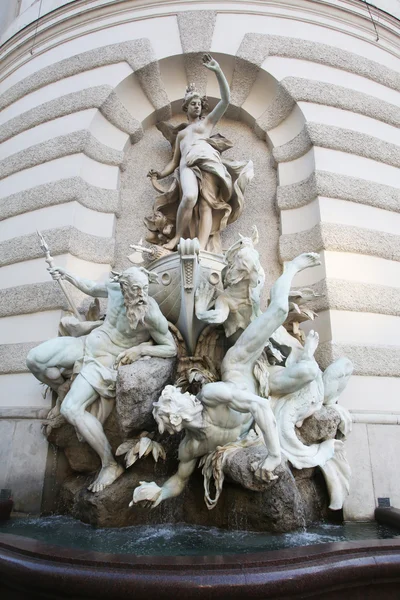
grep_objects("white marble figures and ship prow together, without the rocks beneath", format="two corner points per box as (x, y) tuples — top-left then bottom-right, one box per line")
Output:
(27, 55), (353, 509)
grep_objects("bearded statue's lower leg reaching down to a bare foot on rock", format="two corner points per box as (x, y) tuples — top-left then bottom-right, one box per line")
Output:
(61, 374), (124, 492)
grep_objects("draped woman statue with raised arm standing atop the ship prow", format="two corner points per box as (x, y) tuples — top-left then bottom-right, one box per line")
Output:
(146, 54), (253, 252)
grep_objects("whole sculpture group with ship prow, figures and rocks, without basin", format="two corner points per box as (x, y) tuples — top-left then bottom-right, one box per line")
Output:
(28, 55), (353, 531)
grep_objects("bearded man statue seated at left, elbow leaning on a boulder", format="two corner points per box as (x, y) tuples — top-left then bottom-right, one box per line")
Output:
(27, 267), (177, 492)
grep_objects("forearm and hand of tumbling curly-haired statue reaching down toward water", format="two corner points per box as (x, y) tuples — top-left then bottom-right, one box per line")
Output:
(129, 459), (197, 508)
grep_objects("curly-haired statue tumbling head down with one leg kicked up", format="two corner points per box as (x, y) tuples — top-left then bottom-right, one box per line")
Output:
(131, 253), (320, 506)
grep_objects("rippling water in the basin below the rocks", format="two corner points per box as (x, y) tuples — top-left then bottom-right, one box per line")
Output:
(0, 516), (400, 556)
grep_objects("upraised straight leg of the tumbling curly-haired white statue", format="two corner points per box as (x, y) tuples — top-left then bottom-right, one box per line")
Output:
(221, 252), (320, 370)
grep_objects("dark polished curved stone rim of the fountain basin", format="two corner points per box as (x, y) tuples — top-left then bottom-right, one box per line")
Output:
(0, 534), (400, 600)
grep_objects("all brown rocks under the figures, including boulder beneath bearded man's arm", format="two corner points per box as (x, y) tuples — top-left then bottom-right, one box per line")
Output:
(49, 359), (340, 532)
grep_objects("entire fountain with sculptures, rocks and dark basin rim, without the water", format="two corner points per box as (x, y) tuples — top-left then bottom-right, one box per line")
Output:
(0, 49), (400, 600)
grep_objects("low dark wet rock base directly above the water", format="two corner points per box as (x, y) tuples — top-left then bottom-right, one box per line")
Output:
(59, 458), (328, 533)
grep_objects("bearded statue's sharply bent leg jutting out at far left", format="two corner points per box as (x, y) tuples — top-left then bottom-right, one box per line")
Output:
(26, 337), (84, 392)
